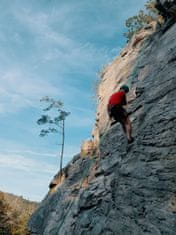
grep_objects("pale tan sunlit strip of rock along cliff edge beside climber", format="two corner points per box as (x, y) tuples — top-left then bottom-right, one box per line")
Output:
(92, 24), (155, 143)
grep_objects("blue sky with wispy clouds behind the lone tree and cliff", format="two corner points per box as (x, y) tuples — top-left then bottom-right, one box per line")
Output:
(0, 0), (146, 201)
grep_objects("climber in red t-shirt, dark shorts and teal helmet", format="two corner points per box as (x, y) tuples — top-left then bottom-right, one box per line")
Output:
(108, 85), (134, 144)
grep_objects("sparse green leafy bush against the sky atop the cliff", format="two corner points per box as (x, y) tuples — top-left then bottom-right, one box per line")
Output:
(124, 0), (159, 41)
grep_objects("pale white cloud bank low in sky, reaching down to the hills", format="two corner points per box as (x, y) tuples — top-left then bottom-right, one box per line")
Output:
(0, 141), (78, 201)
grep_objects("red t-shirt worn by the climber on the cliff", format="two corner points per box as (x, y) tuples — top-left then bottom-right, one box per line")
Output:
(108, 91), (126, 106)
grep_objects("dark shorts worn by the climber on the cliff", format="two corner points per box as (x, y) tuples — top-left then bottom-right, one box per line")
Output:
(108, 105), (128, 123)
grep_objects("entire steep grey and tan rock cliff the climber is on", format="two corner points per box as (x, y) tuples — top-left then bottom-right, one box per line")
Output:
(29, 17), (176, 235)
